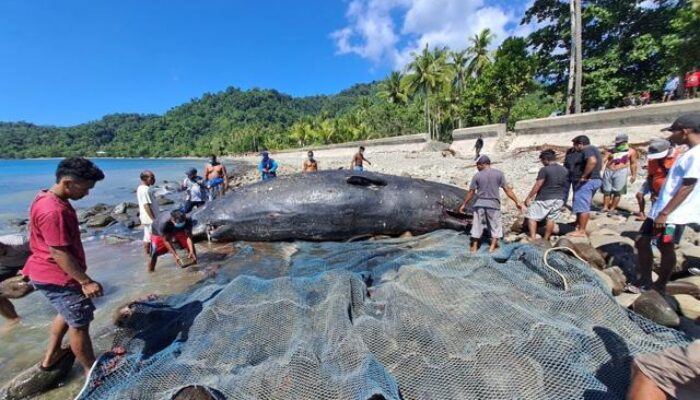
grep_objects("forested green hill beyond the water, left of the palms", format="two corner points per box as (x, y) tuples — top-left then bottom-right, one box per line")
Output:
(0, 83), (386, 158)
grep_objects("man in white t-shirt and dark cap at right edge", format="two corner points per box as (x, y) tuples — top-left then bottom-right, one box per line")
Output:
(636, 113), (700, 293)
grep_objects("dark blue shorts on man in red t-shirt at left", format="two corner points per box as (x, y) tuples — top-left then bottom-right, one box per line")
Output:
(32, 282), (95, 328)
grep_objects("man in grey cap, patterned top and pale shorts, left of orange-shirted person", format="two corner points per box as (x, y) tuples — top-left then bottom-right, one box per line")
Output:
(602, 133), (639, 214)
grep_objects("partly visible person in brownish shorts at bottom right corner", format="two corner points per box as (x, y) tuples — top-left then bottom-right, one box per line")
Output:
(627, 339), (700, 400)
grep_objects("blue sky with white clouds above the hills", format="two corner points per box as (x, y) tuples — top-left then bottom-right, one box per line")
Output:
(0, 0), (534, 126)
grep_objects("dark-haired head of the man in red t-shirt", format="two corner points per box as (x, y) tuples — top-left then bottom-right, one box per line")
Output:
(54, 157), (105, 200)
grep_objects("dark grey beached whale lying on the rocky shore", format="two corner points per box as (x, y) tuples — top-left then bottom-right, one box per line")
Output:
(192, 170), (467, 241)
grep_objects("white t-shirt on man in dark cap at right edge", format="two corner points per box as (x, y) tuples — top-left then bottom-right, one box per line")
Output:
(649, 146), (700, 224)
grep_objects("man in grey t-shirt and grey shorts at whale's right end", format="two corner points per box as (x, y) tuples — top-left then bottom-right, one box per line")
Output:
(459, 155), (523, 253)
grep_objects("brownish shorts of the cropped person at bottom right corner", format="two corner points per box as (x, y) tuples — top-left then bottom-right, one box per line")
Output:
(634, 340), (700, 400)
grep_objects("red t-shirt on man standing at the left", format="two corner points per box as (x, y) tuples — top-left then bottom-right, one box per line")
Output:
(22, 191), (87, 286)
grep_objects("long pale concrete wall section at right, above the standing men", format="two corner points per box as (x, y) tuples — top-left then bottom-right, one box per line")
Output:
(510, 99), (700, 148)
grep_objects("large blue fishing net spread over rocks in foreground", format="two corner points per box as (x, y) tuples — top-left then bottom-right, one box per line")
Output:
(81, 231), (687, 399)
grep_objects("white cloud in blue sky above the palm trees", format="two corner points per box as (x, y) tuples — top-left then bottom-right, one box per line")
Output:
(331, 0), (536, 69)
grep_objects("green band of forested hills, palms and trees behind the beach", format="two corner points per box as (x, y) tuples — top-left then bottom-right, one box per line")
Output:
(0, 0), (700, 158)
